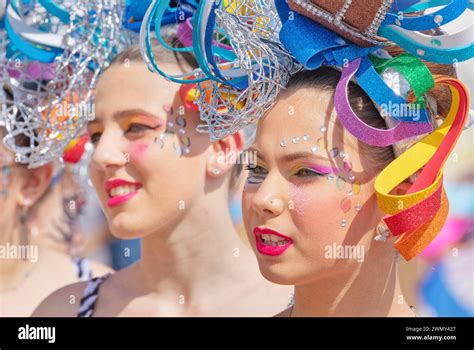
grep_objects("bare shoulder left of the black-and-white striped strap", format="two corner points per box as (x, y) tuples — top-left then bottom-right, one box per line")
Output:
(31, 282), (88, 317)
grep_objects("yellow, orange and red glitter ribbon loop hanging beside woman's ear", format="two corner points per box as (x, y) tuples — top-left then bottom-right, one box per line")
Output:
(374, 77), (469, 260)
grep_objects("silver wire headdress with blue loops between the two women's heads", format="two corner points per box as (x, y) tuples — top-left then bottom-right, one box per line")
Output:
(140, 0), (300, 141)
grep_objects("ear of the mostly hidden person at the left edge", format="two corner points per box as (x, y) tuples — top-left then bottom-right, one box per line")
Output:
(18, 164), (53, 208)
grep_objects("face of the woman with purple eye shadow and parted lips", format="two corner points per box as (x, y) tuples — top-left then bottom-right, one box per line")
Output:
(242, 89), (382, 285)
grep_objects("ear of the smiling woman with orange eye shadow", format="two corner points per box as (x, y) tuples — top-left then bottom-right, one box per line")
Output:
(206, 131), (245, 177)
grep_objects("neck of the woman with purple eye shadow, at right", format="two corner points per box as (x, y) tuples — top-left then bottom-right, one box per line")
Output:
(291, 242), (413, 317)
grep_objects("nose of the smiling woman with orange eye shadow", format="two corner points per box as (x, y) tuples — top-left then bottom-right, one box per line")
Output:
(91, 130), (128, 171)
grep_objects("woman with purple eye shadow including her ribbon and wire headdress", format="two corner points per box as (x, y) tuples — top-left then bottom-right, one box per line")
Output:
(146, 0), (473, 316)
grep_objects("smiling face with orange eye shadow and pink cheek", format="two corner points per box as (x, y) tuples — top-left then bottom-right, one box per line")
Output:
(88, 62), (210, 238)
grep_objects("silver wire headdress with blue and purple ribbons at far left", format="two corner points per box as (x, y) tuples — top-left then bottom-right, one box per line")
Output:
(0, 0), (129, 168)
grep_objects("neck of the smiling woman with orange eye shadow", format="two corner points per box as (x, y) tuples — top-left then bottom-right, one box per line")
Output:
(135, 190), (251, 299)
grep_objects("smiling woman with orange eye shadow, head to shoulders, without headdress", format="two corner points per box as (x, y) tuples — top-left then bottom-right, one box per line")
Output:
(35, 39), (292, 317)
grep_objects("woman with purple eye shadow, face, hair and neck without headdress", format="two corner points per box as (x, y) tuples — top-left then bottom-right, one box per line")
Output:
(243, 60), (466, 317)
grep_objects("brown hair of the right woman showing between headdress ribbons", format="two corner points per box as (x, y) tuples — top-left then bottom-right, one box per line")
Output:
(287, 46), (456, 172)
